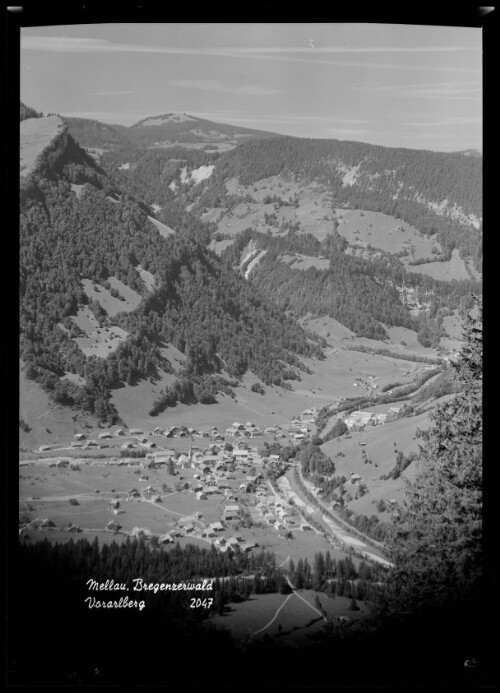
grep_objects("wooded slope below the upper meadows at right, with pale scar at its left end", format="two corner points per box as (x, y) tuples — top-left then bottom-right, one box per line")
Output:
(221, 229), (479, 346)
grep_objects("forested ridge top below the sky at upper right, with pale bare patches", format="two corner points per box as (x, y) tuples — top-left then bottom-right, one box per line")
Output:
(199, 137), (482, 269)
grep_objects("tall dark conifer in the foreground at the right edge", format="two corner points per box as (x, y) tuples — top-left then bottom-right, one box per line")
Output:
(386, 299), (482, 611)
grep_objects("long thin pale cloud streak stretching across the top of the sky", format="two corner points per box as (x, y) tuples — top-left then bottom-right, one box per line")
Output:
(21, 34), (481, 72)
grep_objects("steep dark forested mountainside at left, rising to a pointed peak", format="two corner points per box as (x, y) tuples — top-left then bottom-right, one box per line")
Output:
(20, 112), (322, 421)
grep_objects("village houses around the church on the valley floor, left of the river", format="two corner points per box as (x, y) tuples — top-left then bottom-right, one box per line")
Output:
(19, 407), (328, 552)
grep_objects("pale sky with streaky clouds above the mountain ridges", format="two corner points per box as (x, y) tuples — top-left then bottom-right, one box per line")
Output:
(21, 23), (482, 151)
